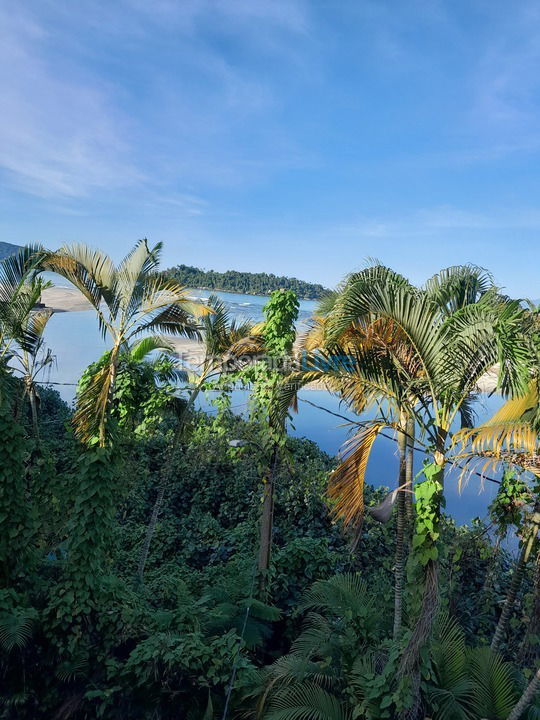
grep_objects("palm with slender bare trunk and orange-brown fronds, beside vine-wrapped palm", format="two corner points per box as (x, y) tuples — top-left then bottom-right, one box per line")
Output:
(294, 265), (508, 637)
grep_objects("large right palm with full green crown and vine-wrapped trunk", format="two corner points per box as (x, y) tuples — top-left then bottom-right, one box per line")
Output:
(282, 265), (527, 716)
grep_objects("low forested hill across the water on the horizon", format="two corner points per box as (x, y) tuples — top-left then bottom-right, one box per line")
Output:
(165, 265), (328, 300)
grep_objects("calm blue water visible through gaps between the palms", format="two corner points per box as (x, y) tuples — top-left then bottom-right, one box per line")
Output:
(42, 290), (501, 523)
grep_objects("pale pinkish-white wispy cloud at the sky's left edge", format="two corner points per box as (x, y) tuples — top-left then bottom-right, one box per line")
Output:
(0, 5), (142, 196)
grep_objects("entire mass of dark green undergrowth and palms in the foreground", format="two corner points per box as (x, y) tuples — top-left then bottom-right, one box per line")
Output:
(0, 243), (540, 720)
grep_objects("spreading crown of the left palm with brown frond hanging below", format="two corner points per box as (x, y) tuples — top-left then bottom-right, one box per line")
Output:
(41, 240), (209, 447)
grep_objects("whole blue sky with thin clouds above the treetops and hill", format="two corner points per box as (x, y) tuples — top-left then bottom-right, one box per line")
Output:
(0, 0), (540, 297)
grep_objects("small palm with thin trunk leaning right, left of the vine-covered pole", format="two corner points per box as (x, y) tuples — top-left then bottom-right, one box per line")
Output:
(137, 295), (263, 585)
